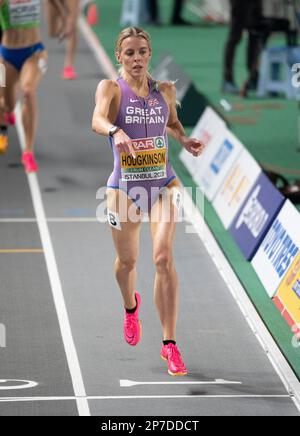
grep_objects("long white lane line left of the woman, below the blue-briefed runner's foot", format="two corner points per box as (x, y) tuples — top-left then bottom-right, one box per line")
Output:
(16, 104), (91, 416)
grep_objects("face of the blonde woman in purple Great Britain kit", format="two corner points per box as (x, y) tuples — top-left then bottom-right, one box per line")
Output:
(117, 37), (151, 78)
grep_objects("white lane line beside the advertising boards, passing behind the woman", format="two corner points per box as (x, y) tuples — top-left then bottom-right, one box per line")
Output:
(81, 12), (300, 411)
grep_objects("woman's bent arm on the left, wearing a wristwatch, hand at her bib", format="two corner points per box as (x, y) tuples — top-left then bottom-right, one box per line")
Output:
(92, 80), (135, 158)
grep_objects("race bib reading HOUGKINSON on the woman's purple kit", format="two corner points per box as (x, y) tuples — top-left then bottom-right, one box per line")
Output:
(120, 136), (168, 182)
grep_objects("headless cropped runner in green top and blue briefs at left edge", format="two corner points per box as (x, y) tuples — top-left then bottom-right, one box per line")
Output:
(0, 0), (68, 172)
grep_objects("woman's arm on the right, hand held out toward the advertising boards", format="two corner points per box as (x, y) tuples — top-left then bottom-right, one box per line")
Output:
(161, 83), (204, 157)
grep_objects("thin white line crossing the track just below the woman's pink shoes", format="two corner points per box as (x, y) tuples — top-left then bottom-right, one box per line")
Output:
(0, 394), (290, 403)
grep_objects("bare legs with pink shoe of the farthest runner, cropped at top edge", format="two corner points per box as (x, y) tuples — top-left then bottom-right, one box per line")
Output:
(46, 0), (80, 80)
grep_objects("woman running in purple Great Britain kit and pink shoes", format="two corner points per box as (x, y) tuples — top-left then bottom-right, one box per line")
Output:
(93, 27), (204, 376)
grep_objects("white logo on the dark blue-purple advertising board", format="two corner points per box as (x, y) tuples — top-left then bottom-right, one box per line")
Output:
(236, 186), (269, 239)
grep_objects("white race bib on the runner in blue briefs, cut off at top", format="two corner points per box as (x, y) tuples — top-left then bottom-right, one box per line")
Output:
(9, 0), (41, 27)
